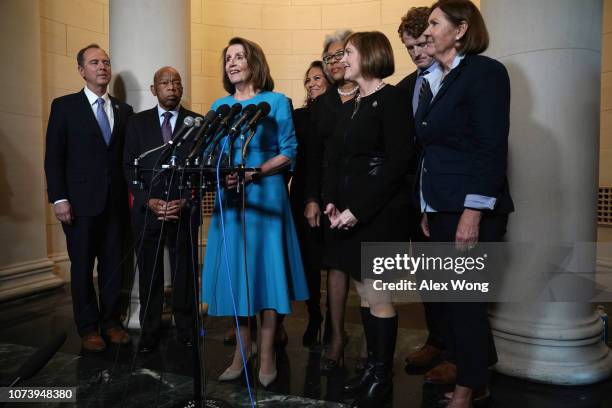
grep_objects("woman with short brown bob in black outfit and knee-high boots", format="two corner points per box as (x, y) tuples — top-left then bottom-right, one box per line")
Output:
(324, 31), (414, 407)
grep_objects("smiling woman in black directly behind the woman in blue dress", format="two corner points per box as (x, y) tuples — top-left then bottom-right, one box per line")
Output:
(289, 61), (330, 347)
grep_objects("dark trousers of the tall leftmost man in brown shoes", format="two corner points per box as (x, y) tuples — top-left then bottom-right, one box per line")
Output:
(62, 195), (127, 336)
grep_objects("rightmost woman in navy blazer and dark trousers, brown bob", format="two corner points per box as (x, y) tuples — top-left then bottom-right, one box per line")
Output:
(415, 0), (514, 408)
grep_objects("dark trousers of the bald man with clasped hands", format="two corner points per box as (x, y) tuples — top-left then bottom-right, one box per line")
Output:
(134, 211), (200, 336)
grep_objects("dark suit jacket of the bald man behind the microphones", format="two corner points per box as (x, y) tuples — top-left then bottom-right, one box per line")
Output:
(123, 106), (201, 228)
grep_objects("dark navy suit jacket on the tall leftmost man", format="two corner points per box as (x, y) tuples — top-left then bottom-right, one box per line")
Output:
(45, 90), (133, 216)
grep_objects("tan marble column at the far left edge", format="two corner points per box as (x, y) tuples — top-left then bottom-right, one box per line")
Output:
(0, 0), (63, 302)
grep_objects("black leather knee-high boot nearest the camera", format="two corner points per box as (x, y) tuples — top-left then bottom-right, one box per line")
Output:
(351, 315), (397, 408)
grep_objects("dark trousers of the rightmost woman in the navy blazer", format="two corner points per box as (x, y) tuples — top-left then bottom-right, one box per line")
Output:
(427, 212), (508, 389)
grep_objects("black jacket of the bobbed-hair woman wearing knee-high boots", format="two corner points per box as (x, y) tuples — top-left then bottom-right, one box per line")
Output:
(323, 85), (414, 223)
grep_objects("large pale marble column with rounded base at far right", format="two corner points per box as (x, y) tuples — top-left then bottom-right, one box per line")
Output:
(481, 0), (612, 385)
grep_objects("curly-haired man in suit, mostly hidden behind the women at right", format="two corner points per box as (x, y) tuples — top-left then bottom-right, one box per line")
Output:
(397, 7), (455, 384)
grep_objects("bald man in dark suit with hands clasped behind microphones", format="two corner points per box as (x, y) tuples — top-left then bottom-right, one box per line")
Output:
(124, 67), (201, 353)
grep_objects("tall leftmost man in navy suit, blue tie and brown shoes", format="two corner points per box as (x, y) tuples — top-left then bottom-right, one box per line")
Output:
(45, 44), (133, 351)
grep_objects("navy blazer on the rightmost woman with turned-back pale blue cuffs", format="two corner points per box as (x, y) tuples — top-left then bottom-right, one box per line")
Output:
(415, 55), (514, 213)
